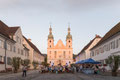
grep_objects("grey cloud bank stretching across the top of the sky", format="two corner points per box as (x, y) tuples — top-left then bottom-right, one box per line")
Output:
(0, 0), (120, 13)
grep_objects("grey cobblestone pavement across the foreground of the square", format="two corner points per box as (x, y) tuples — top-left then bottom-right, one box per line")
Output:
(0, 71), (120, 80)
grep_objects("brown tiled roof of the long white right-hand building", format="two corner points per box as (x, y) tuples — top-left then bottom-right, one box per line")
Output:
(91, 22), (120, 50)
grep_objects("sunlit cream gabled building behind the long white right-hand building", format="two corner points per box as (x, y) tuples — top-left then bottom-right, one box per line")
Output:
(76, 35), (101, 62)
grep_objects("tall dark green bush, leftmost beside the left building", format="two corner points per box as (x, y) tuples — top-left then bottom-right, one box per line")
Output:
(12, 57), (21, 73)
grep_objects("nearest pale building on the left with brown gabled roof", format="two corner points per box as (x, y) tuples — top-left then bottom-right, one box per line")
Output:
(0, 21), (29, 71)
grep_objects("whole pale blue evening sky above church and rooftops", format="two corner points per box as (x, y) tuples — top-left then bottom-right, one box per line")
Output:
(0, 0), (120, 54)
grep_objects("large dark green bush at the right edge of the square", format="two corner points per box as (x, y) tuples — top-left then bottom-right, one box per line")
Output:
(106, 55), (120, 76)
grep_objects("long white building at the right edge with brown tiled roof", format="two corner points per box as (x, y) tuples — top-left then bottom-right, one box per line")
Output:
(91, 23), (120, 68)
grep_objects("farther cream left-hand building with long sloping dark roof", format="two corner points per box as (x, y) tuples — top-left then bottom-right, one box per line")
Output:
(23, 36), (44, 69)
